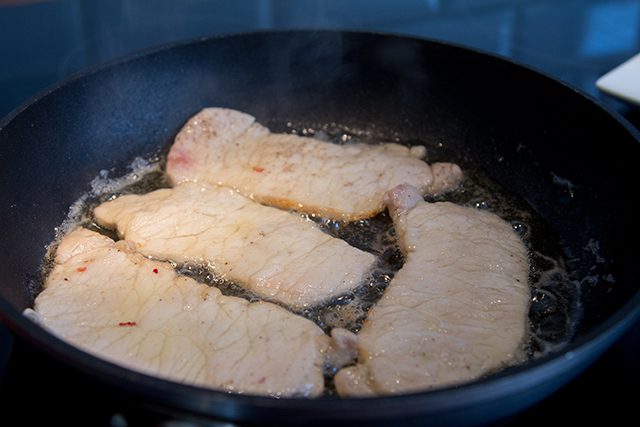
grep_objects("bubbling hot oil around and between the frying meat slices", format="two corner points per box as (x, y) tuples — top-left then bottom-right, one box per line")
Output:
(38, 124), (580, 394)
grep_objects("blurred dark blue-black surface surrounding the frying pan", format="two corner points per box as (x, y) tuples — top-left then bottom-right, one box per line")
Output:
(0, 0), (640, 426)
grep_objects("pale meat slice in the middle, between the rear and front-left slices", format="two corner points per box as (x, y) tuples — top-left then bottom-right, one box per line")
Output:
(94, 182), (375, 308)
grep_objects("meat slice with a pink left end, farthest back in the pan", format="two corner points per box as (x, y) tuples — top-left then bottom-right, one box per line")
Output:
(167, 108), (462, 220)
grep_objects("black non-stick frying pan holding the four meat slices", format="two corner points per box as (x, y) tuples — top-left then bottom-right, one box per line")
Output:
(0, 32), (640, 425)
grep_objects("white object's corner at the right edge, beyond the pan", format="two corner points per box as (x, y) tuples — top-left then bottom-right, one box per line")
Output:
(596, 53), (640, 105)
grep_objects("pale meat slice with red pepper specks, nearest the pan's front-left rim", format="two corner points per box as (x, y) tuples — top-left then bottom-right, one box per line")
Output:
(31, 228), (329, 396)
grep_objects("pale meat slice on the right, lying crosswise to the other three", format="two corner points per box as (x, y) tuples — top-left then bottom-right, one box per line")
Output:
(335, 186), (530, 396)
